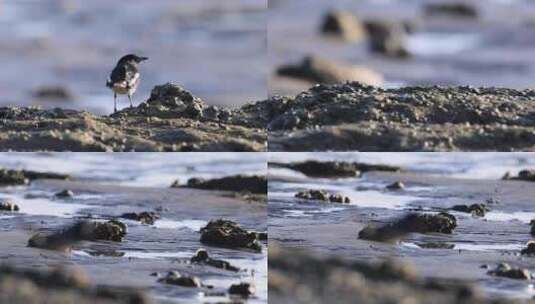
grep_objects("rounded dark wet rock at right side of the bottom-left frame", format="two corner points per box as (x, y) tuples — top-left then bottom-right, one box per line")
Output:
(201, 219), (262, 252)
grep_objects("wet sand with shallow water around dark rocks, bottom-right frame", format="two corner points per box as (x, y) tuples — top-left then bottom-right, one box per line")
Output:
(269, 165), (535, 299)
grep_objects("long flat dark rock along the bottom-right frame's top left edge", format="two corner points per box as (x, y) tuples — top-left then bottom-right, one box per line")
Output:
(270, 160), (401, 177)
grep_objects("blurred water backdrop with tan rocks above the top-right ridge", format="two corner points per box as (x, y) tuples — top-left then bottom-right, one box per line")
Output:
(268, 0), (535, 95)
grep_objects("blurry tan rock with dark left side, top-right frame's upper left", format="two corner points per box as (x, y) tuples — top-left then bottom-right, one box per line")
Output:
(320, 11), (366, 42)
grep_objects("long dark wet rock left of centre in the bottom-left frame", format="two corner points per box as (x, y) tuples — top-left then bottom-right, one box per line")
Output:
(28, 220), (127, 252)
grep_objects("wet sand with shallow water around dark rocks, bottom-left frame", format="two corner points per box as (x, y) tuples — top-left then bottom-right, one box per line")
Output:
(0, 180), (267, 303)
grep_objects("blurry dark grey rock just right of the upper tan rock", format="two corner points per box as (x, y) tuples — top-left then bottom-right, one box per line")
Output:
(366, 21), (410, 58)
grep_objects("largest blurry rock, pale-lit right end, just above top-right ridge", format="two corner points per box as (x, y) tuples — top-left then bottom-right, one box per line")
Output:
(277, 56), (384, 86)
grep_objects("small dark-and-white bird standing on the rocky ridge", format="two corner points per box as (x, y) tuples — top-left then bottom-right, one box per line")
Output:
(106, 54), (149, 113)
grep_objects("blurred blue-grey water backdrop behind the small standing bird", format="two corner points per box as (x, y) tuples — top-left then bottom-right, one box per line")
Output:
(0, 0), (267, 114)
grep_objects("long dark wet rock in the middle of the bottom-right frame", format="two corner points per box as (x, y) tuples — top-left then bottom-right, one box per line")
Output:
(359, 212), (457, 242)
